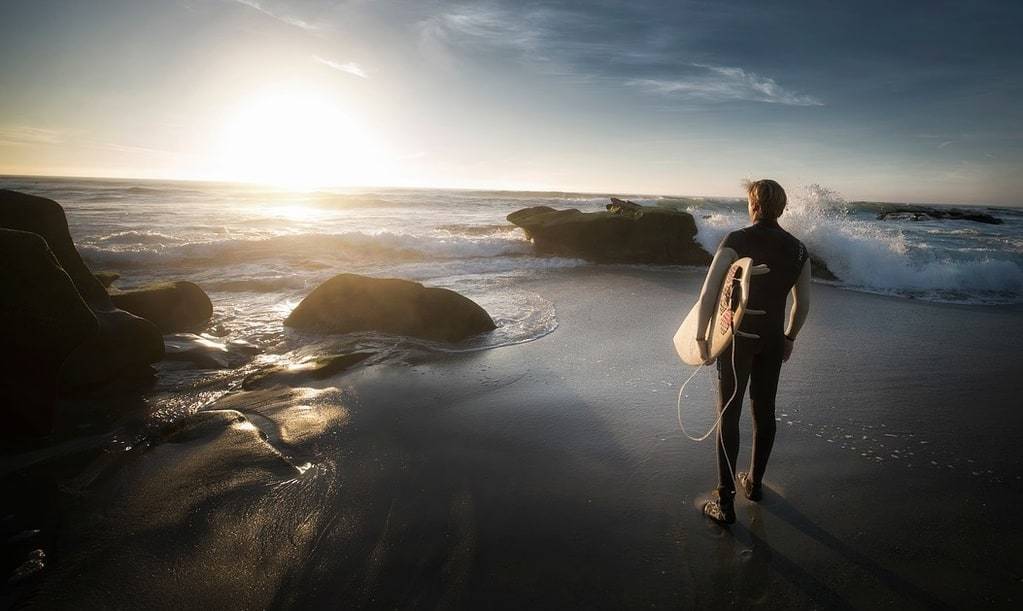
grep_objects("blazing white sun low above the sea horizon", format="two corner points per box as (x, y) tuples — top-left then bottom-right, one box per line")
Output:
(216, 89), (386, 188)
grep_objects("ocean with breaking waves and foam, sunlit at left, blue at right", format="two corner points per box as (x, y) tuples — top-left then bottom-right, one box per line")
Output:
(0, 177), (1023, 358)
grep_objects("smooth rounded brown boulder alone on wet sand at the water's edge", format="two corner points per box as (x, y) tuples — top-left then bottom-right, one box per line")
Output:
(284, 273), (495, 342)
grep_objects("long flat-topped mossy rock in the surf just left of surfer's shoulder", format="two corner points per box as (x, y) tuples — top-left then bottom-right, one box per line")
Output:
(507, 200), (711, 265)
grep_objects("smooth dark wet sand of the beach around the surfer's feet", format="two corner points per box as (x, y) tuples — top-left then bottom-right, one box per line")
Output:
(7, 267), (1023, 609)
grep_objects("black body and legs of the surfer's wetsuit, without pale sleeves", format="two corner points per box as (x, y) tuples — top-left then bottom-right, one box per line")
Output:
(717, 220), (809, 499)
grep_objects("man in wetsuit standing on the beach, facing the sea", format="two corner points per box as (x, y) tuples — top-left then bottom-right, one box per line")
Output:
(697, 180), (810, 524)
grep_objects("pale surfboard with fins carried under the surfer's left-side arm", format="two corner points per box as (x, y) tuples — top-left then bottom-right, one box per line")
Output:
(673, 257), (753, 365)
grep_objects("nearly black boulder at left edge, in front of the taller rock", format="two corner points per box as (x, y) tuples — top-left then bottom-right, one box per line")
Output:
(0, 229), (99, 437)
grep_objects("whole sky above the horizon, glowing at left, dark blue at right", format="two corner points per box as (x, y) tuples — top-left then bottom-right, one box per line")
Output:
(0, 0), (1023, 206)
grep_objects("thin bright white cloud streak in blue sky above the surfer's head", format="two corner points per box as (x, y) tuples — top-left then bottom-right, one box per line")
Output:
(629, 63), (824, 106)
